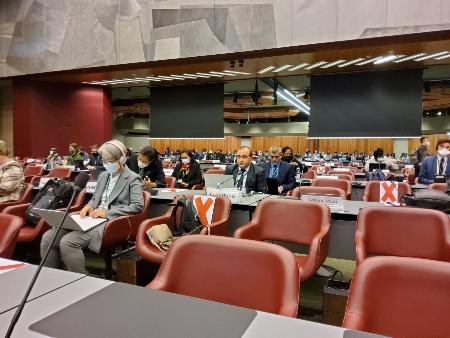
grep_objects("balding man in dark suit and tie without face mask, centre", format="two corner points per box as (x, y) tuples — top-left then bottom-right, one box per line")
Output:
(225, 147), (267, 193)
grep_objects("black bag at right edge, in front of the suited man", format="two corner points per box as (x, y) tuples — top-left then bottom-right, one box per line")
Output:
(402, 189), (450, 213)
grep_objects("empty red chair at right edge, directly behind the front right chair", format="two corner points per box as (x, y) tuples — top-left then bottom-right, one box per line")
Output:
(355, 207), (450, 264)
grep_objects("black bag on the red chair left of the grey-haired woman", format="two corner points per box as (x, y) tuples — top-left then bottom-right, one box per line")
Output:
(25, 179), (73, 224)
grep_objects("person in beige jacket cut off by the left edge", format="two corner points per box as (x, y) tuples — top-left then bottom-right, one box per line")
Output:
(0, 140), (25, 202)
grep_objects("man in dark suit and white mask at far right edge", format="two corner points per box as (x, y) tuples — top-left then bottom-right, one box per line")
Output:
(419, 139), (450, 184)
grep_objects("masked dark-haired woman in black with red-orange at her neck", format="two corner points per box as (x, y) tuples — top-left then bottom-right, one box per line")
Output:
(172, 150), (202, 189)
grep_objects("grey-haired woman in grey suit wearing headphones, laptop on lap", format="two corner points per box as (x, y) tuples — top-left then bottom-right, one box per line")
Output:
(41, 140), (144, 273)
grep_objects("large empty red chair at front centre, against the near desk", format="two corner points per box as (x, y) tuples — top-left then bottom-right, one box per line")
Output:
(148, 235), (300, 318)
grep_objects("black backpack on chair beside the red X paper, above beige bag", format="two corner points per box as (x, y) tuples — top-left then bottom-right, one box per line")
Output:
(170, 197), (202, 237)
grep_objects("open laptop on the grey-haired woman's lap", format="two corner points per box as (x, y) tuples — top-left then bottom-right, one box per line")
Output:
(33, 208), (108, 232)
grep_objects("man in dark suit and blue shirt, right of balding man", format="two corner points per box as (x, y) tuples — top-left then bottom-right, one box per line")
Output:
(264, 147), (295, 194)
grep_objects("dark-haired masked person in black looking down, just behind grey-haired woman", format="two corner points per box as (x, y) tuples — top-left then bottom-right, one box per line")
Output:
(137, 146), (166, 188)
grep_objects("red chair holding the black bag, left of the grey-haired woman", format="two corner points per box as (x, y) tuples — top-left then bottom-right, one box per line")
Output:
(3, 189), (86, 243)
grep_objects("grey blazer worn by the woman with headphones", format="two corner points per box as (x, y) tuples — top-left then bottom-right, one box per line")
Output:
(88, 167), (144, 253)
